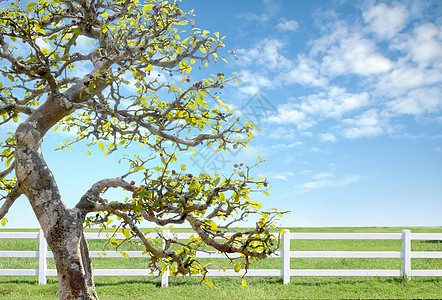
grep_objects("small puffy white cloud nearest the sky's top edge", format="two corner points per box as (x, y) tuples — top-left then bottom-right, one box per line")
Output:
(362, 3), (408, 39)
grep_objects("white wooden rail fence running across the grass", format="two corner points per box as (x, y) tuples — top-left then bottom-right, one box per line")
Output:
(0, 230), (442, 286)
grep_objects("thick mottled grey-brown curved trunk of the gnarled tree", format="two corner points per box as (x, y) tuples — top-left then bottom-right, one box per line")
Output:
(15, 97), (98, 299)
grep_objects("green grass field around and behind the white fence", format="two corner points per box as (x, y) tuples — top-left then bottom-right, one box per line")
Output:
(0, 227), (442, 299)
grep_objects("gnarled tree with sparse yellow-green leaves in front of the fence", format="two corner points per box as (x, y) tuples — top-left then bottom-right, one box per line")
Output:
(0, 0), (281, 299)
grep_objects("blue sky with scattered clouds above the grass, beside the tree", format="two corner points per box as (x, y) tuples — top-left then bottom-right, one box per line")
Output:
(1, 0), (442, 227)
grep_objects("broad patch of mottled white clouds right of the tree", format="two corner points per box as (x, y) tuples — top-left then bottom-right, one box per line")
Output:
(233, 3), (442, 142)
